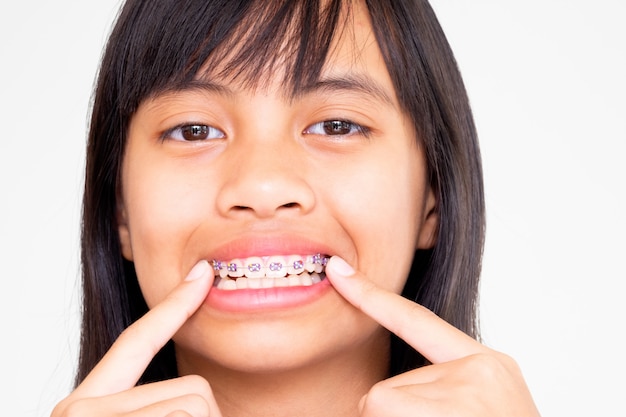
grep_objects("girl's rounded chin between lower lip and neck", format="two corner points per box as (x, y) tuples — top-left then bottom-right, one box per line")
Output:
(175, 302), (386, 374)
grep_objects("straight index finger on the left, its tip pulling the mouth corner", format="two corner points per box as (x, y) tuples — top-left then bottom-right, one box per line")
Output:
(75, 261), (213, 397)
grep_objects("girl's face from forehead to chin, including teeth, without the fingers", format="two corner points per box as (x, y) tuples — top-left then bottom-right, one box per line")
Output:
(119, 2), (437, 373)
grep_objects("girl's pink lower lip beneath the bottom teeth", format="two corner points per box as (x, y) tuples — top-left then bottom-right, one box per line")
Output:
(206, 279), (331, 312)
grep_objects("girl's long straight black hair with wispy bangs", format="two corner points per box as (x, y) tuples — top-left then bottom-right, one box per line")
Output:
(76, 0), (484, 384)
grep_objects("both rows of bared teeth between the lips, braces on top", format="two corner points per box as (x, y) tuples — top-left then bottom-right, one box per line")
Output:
(212, 253), (330, 290)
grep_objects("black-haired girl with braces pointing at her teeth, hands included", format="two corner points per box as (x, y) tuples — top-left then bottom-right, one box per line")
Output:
(53, 0), (537, 417)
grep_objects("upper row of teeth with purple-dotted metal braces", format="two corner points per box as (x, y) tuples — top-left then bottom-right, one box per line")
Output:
(212, 254), (329, 278)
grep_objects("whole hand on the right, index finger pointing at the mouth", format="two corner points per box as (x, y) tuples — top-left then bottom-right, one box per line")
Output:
(326, 257), (539, 417)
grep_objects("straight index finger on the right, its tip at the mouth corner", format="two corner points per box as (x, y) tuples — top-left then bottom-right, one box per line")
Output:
(326, 256), (487, 363)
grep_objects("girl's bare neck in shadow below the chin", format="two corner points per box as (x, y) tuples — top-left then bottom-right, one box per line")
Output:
(177, 332), (389, 417)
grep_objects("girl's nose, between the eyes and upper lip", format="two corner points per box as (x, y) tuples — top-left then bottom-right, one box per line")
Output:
(217, 140), (315, 219)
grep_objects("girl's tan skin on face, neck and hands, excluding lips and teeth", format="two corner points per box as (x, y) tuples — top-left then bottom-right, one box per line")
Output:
(53, 1), (538, 417)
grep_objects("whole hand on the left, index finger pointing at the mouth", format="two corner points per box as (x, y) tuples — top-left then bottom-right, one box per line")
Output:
(51, 261), (221, 417)
